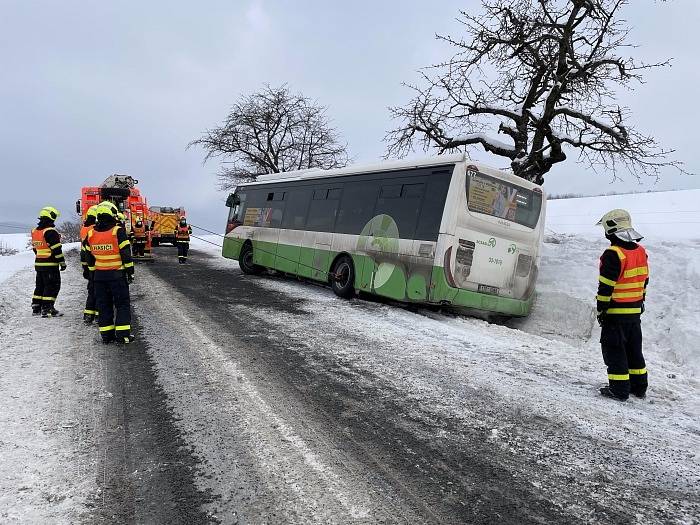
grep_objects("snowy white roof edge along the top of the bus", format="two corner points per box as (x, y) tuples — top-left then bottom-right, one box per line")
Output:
(239, 153), (537, 189)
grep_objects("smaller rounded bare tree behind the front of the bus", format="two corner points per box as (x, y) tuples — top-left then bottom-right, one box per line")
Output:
(187, 85), (349, 189)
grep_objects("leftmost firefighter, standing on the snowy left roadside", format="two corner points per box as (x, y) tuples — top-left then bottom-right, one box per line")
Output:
(31, 206), (66, 317)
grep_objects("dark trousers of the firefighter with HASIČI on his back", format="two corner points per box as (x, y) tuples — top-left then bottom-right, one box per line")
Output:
(95, 273), (131, 341)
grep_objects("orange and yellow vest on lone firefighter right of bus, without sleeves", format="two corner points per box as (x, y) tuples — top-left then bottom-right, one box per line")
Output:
(598, 245), (649, 315)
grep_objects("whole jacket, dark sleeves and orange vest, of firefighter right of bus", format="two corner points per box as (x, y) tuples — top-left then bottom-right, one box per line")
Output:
(597, 243), (649, 318)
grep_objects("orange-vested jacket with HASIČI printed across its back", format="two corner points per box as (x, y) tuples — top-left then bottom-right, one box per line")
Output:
(83, 222), (134, 281)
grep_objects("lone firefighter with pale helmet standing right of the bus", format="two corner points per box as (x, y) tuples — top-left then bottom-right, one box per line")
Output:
(596, 209), (649, 401)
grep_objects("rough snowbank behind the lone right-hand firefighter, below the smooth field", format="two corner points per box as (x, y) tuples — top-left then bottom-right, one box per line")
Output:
(512, 236), (700, 380)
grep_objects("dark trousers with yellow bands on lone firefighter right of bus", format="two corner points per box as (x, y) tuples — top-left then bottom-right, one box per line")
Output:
(600, 316), (647, 398)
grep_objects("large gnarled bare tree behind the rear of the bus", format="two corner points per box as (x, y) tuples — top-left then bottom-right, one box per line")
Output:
(386, 0), (683, 184)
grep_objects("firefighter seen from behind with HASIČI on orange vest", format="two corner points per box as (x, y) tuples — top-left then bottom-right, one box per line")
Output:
(85, 205), (134, 344)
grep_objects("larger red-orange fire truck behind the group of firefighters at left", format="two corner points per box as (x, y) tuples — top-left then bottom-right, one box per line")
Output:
(75, 174), (152, 260)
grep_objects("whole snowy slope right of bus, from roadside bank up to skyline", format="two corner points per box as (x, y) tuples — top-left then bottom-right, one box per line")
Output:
(532, 190), (700, 378)
